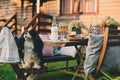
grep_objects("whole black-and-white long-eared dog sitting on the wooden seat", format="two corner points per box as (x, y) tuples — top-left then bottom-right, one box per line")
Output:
(19, 30), (43, 69)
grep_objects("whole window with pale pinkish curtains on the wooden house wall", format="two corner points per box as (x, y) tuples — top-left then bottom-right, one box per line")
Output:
(60, 0), (98, 15)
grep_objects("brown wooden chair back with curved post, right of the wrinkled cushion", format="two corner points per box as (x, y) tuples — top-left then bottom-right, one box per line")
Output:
(91, 27), (120, 80)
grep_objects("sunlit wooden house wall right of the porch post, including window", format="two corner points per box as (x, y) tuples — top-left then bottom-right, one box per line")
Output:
(40, 0), (120, 27)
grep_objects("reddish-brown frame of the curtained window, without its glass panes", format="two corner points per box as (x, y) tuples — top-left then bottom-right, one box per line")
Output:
(60, 0), (98, 15)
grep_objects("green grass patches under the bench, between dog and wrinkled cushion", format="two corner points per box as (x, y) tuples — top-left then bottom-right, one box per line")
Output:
(39, 61), (83, 80)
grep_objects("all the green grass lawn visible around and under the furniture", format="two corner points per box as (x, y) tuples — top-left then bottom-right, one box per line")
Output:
(0, 61), (120, 80)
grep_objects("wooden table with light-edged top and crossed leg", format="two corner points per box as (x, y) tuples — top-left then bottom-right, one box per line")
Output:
(44, 39), (88, 80)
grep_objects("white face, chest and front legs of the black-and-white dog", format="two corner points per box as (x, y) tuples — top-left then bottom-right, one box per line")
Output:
(22, 32), (41, 69)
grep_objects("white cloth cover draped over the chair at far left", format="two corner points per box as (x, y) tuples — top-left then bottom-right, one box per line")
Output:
(0, 27), (20, 63)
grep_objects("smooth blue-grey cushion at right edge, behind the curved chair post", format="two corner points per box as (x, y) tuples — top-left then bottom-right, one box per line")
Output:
(101, 46), (120, 72)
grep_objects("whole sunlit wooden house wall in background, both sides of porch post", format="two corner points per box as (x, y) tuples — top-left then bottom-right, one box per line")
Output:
(0, 0), (120, 33)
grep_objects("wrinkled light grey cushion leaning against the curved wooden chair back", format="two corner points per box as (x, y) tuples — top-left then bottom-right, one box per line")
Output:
(84, 34), (103, 77)
